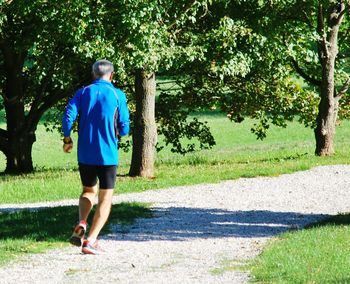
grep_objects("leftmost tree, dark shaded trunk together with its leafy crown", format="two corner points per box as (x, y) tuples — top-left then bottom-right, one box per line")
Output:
(0, 0), (110, 174)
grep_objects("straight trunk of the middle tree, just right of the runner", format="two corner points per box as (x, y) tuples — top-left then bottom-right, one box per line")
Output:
(129, 69), (157, 178)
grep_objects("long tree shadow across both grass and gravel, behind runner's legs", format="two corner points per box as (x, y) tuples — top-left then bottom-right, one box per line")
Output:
(0, 203), (344, 242)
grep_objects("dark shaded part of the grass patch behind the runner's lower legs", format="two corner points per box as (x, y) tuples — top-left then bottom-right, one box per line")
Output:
(0, 203), (151, 242)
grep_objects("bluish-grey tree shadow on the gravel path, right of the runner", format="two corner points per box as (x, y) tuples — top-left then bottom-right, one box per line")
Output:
(109, 207), (329, 241)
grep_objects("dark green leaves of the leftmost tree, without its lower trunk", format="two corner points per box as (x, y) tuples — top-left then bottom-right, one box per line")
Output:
(0, 0), (96, 131)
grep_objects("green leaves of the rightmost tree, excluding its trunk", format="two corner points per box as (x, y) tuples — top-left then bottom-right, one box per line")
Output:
(174, 0), (349, 139)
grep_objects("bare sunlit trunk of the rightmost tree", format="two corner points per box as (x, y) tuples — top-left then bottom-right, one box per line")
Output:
(315, 1), (345, 156)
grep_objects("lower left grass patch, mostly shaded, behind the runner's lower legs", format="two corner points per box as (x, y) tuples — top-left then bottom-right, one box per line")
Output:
(0, 203), (151, 265)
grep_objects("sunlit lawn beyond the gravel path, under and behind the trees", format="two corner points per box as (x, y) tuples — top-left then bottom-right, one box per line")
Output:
(0, 114), (350, 203)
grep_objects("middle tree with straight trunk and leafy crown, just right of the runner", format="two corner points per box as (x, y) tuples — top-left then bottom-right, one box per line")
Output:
(98, 0), (213, 177)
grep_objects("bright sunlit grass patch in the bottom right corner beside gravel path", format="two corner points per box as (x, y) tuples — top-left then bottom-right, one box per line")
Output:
(252, 214), (350, 284)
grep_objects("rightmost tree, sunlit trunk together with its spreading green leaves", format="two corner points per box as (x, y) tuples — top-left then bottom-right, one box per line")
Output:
(176, 0), (350, 156)
